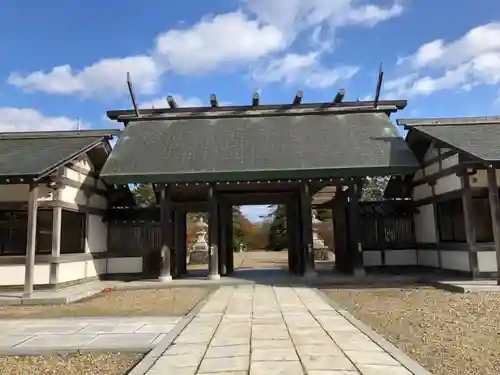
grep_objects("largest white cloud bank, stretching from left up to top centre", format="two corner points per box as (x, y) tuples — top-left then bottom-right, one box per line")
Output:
(8, 0), (403, 99)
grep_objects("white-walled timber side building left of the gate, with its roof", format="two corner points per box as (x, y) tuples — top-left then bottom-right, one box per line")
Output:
(0, 130), (142, 295)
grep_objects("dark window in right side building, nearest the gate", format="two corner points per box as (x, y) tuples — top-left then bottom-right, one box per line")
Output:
(436, 198), (465, 242)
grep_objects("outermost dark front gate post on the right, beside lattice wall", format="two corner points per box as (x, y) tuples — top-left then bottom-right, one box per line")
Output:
(349, 178), (365, 276)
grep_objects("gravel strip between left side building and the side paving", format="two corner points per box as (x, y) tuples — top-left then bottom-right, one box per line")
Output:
(0, 287), (210, 318)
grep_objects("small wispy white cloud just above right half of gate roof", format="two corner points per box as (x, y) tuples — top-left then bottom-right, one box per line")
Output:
(254, 52), (359, 88)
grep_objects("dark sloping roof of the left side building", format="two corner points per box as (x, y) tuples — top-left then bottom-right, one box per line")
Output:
(0, 132), (103, 179)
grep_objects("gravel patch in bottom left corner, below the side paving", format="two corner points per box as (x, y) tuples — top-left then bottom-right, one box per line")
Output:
(0, 353), (143, 375)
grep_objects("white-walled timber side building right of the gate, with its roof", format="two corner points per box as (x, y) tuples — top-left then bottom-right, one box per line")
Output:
(386, 117), (500, 278)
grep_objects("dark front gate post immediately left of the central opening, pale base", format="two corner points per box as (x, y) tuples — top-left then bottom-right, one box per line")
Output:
(208, 184), (220, 280)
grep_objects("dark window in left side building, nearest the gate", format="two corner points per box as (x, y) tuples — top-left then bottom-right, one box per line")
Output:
(61, 210), (87, 254)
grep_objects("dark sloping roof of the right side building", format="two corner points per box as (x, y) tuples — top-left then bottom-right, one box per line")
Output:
(408, 123), (500, 161)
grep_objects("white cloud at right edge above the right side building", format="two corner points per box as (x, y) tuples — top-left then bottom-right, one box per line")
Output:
(385, 23), (500, 96)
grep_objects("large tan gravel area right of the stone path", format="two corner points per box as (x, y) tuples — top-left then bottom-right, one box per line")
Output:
(325, 288), (500, 375)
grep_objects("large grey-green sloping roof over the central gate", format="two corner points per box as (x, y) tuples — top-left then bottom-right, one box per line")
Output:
(101, 113), (418, 184)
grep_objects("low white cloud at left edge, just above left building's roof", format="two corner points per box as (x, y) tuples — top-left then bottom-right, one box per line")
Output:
(0, 107), (89, 132)
